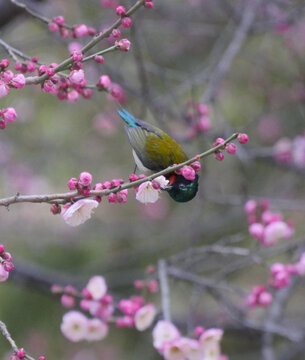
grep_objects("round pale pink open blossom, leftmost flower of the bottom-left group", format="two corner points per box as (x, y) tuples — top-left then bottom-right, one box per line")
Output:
(60, 310), (88, 342)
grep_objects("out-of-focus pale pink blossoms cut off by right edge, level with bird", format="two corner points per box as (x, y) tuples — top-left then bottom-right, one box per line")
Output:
(273, 132), (305, 169)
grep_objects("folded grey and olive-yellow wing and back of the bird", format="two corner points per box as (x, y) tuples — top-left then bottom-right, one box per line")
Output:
(125, 120), (187, 171)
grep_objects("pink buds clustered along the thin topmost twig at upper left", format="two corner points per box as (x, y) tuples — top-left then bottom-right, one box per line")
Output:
(48, 15), (97, 39)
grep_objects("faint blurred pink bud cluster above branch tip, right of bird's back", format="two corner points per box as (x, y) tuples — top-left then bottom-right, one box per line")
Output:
(185, 101), (211, 140)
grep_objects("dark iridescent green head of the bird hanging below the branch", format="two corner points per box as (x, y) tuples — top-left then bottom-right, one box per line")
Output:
(167, 174), (199, 202)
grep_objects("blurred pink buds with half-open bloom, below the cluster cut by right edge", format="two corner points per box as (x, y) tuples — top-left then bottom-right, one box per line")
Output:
(245, 200), (294, 246)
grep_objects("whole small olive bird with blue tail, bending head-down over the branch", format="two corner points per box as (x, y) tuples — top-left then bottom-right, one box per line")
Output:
(117, 108), (199, 202)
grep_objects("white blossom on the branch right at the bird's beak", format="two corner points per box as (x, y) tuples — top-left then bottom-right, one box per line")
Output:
(136, 176), (169, 204)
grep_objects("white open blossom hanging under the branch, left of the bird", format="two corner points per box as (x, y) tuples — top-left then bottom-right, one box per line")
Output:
(61, 199), (99, 226)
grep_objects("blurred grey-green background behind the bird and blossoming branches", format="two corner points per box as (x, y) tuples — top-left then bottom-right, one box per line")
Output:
(0, 0), (305, 360)
